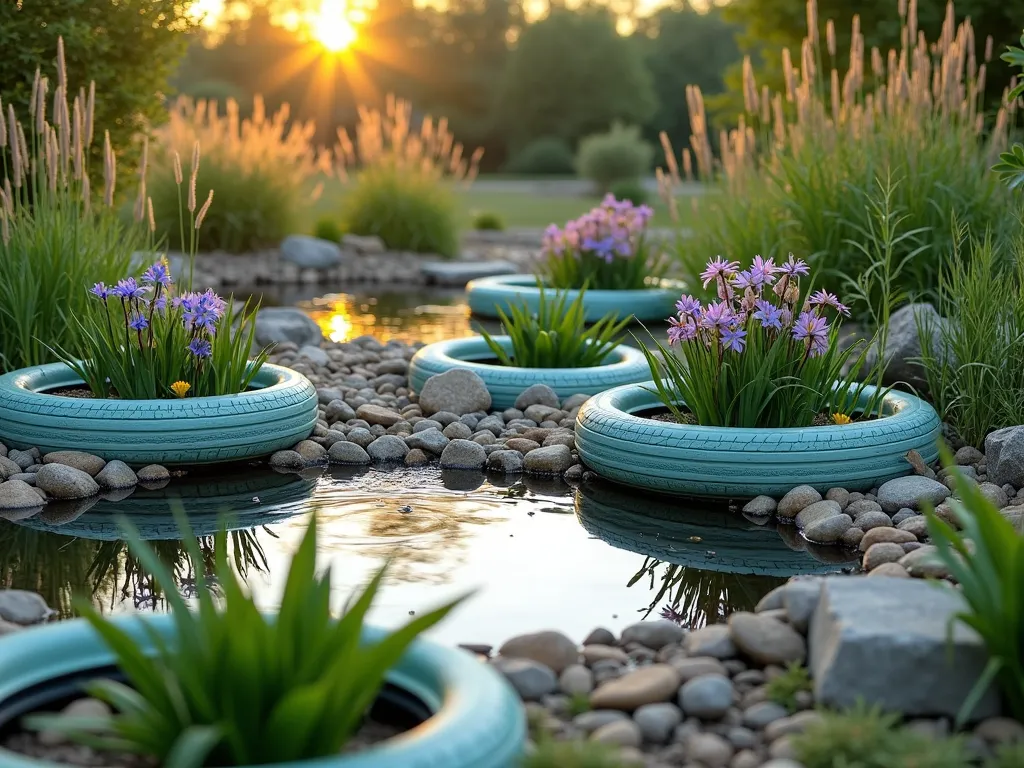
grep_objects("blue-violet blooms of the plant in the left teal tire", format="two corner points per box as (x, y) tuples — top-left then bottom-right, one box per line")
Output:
(89, 260), (227, 359)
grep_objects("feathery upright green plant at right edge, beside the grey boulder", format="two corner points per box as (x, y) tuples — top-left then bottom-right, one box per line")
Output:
(918, 228), (1024, 446)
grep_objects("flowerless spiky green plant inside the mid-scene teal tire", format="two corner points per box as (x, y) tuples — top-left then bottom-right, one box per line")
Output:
(479, 284), (631, 368)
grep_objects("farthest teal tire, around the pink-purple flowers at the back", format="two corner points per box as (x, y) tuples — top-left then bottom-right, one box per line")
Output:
(466, 274), (686, 323)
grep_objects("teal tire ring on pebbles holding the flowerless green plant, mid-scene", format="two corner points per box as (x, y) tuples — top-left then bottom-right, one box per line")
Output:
(409, 336), (650, 411)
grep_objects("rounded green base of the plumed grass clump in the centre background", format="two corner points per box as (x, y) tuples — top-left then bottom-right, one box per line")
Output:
(342, 165), (459, 258)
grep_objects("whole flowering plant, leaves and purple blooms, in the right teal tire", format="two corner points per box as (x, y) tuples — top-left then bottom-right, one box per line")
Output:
(642, 254), (884, 427)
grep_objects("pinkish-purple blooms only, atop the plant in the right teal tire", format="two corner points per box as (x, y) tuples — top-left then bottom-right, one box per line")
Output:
(669, 254), (850, 358)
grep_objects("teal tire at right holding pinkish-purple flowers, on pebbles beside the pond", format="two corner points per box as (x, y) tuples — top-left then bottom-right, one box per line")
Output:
(575, 382), (940, 499)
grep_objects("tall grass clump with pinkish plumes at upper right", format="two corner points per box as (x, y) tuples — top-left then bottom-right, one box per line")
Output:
(662, 0), (1017, 307)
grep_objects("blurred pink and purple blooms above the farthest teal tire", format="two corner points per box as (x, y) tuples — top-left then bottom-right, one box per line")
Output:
(544, 195), (654, 264)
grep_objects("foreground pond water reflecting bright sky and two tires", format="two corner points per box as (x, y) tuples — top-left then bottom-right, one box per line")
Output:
(0, 468), (850, 643)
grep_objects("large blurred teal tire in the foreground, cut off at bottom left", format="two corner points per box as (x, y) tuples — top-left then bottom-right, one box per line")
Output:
(0, 614), (526, 768)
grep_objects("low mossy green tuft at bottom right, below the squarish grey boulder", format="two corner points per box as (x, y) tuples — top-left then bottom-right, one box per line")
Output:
(792, 702), (969, 768)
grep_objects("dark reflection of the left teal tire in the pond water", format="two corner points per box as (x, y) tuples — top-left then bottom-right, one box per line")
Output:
(14, 471), (316, 542)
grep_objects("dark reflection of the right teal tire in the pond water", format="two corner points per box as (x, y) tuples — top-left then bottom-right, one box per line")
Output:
(575, 482), (856, 578)
